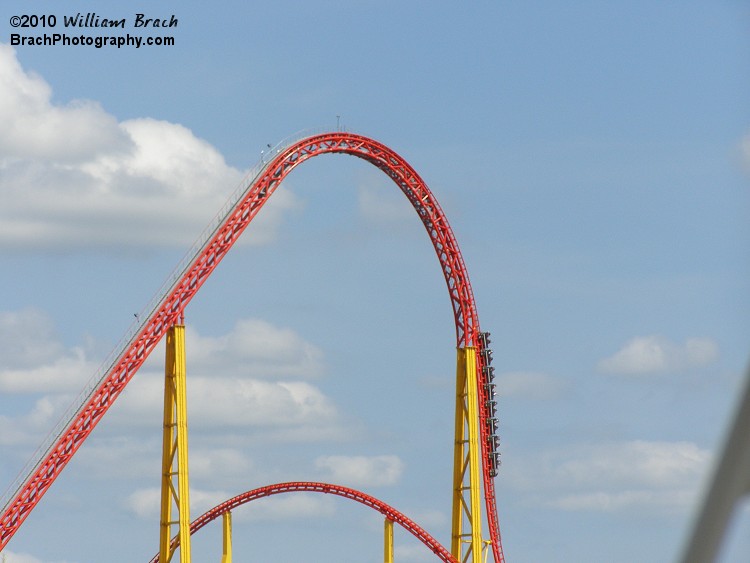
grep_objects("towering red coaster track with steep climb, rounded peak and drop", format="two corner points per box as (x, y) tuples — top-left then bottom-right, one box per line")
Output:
(0, 131), (504, 563)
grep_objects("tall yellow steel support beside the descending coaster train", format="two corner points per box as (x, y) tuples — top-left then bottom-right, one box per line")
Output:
(451, 347), (482, 563)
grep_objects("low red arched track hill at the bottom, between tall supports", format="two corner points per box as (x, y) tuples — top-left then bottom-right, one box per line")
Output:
(150, 481), (458, 563)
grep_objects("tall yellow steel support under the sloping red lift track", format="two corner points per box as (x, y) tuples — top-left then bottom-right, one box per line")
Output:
(159, 325), (190, 563)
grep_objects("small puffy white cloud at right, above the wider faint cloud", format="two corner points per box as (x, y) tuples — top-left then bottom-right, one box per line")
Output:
(597, 335), (719, 375)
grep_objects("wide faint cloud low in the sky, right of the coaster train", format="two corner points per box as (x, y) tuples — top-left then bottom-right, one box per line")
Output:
(503, 440), (711, 513)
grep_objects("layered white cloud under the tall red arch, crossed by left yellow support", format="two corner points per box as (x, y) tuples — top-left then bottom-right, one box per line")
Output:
(105, 319), (346, 441)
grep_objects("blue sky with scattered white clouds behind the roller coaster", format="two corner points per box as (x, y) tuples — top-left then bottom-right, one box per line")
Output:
(0, 0), (750, 563)
